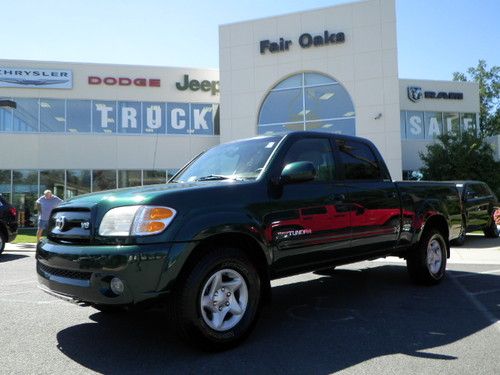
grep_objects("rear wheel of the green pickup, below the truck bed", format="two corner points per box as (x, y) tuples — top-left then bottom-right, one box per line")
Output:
(406, 230), (447, 285)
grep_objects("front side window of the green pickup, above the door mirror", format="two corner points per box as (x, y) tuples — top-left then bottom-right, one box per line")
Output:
(283, 138), (335, 182)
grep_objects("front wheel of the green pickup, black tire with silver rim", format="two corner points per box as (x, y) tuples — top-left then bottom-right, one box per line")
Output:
(174, 247), (261, 351)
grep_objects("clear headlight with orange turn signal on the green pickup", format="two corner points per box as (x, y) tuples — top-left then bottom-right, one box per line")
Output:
(99, 206), (177, 237)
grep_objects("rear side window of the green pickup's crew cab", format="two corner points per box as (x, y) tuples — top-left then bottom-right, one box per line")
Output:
(337, 140), (382, 180)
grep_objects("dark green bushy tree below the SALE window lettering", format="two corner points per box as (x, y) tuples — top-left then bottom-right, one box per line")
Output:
(420, 131), (500, 197)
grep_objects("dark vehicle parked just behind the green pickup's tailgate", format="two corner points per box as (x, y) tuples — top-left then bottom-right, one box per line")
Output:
(453, 181), (500, 246)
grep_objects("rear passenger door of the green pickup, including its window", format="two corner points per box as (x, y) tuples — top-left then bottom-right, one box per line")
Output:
(335, 139), (401, 255)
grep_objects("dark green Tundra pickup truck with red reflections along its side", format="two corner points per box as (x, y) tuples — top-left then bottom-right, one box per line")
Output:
(36, 132), (462, 349)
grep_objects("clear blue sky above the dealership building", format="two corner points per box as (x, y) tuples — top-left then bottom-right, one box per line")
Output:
(0, 0), (500, 80)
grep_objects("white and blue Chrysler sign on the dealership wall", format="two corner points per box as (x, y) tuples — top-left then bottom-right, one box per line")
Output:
(0, 67), (73, 89)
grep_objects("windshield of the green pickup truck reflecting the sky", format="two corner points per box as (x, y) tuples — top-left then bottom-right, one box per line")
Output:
(172, 137), (281, 182)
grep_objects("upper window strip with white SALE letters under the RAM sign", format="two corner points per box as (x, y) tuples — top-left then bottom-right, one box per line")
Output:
(401, 111), (478, 140)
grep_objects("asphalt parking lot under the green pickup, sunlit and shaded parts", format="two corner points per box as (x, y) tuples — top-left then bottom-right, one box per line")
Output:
(0, 236), (500, 374)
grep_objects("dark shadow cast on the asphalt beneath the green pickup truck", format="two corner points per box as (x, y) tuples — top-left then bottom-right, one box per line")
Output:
(57, 265), (500, 374)
